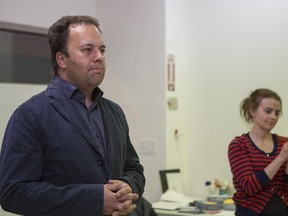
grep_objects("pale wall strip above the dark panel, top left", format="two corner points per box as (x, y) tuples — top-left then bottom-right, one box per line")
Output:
(0, 0), (96, 28)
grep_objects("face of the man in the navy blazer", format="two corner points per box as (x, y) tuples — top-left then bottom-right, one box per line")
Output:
(59, 24), (106, 91)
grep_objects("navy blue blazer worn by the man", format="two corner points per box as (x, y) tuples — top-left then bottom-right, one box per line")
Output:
(0, 79), (145, 216)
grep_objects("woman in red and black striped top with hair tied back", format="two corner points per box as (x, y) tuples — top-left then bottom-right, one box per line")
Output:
(228, 89), (288, 216)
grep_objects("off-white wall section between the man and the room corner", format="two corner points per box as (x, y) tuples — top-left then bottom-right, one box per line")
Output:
(96, 0), (166, 201)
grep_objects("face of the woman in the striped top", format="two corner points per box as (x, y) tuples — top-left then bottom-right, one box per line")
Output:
(251, 98), (282, 132)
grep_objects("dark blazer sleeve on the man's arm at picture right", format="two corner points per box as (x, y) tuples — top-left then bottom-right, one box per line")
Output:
(101, 99), (145, 196)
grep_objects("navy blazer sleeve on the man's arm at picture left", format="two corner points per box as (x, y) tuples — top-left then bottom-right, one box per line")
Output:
(0, 106), (103, 216)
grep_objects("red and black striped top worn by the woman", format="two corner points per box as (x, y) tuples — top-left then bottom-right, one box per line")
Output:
(228, 134), (288, 213)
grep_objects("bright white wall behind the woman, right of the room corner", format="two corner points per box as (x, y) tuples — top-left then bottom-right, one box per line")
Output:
(166, 0), (288, 197)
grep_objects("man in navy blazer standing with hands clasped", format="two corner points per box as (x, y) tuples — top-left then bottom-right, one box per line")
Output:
(0, 16), (145, 216)
